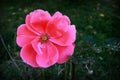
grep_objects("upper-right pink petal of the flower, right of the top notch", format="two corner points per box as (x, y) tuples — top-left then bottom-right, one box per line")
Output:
(46, 12), (70, 37)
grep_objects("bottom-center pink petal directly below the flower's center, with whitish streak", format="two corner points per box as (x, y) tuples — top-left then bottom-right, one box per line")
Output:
(33, 42), (58, 68)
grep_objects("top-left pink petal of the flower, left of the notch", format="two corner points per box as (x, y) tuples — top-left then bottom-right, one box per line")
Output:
(26, 10), (51, 33)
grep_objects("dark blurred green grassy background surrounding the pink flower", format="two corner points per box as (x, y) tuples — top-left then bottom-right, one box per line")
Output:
(0, 0), (120, 80)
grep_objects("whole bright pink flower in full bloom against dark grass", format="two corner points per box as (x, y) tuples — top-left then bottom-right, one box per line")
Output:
(16, 9), (76, 68)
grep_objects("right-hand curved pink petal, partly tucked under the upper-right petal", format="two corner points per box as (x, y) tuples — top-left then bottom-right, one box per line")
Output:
(50, 25), (76, 46)
